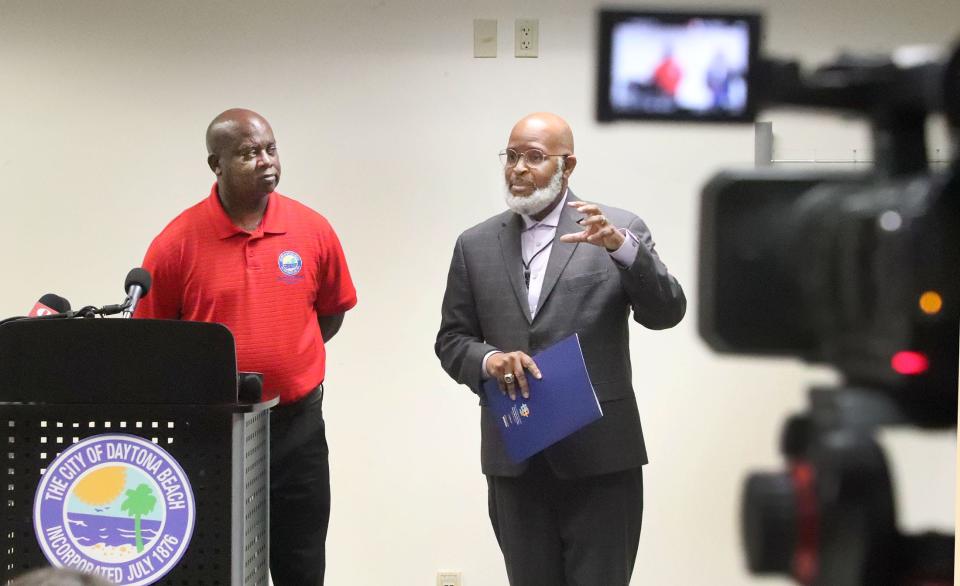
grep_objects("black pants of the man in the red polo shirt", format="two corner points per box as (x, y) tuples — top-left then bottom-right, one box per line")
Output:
(270, 385), (330, 586)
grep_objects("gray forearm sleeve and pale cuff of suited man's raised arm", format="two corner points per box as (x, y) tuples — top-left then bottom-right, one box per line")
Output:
(620, 217), (687, 330)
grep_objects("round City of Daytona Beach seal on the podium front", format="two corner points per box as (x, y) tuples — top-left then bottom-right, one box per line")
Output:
(33, 434), (196, 586)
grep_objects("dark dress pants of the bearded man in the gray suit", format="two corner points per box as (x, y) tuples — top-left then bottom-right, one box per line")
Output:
(487, 456), (643, 586)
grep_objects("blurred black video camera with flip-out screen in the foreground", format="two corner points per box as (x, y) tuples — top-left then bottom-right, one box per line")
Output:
(598, 11), (960, 586)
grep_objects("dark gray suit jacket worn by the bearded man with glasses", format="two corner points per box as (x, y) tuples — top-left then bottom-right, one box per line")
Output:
(435, 192), (686, 478)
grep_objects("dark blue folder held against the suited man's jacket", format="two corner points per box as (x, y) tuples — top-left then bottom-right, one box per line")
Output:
(483, 334), (603, 462)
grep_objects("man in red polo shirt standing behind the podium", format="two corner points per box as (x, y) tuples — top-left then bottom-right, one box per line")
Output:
(136, 109), (357, 586)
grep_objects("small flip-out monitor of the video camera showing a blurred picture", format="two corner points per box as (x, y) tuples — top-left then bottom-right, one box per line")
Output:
(598, 12), (757, 121)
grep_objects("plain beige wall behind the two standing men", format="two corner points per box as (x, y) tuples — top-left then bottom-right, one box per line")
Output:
(0, 0), (960, 586)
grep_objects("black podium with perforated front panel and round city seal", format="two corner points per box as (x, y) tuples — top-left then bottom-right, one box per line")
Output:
(0, 319), (277, 586)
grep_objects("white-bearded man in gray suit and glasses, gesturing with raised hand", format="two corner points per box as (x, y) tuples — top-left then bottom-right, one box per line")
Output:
(435, 113), (686, 586)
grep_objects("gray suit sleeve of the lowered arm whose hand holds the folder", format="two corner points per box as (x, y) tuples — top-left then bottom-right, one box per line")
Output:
(434, 237), (496, 394)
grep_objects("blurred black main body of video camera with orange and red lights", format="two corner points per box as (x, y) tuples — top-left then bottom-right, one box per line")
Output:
(699, 168), (960, 427)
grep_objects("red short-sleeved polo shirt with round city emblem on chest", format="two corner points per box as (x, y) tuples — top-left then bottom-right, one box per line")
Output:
(135, 184), (357, 403)
